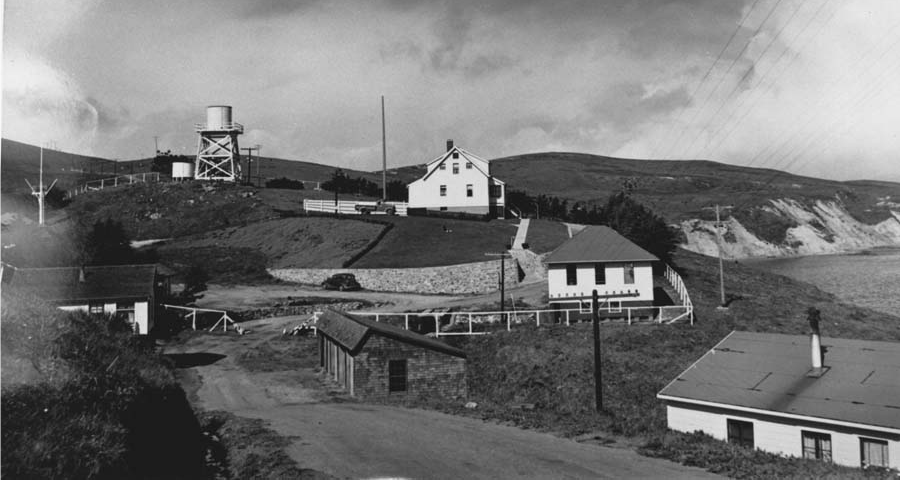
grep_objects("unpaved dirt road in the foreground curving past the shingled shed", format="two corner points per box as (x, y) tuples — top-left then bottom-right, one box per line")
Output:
(168, 317), (717, 479)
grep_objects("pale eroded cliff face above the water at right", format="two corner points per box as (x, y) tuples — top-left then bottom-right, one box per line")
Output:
(679, 199), (900, 258)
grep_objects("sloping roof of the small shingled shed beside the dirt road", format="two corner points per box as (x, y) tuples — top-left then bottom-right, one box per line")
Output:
(316, 310), (466, 358)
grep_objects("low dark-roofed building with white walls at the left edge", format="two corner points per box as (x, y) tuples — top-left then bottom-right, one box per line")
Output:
(4, 265), (164, 335)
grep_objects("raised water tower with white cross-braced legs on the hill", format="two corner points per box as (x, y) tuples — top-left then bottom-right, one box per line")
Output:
(194, 105), (244, 182)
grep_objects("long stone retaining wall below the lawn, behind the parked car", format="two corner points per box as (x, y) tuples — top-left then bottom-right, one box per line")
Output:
(269, 259), (519, 294)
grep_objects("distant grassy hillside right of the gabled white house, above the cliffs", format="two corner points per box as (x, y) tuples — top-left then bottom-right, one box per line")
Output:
(491, 152), (900, 223)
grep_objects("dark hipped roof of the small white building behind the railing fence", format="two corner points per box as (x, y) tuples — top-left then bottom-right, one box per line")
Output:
(546, 225), (659, 264)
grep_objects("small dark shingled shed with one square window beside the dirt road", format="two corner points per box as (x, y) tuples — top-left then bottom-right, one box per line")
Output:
(316, 310), (466, 399)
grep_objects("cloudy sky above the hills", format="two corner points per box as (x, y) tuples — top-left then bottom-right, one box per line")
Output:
(2, 0), (900, 181)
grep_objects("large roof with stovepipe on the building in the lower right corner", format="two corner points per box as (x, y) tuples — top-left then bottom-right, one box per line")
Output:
(658, 331), (900, 433)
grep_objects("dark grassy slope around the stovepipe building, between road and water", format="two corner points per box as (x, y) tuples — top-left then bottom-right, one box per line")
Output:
(430, 250), (900, 478)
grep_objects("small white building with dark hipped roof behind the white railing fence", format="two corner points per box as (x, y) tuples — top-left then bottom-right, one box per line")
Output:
(546, 226), (659, 313)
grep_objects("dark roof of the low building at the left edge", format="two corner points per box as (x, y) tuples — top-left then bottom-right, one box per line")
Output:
(10, 264), (156, 303)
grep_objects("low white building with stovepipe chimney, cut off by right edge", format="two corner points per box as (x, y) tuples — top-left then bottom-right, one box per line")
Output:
(657, 327), (900, 468)
